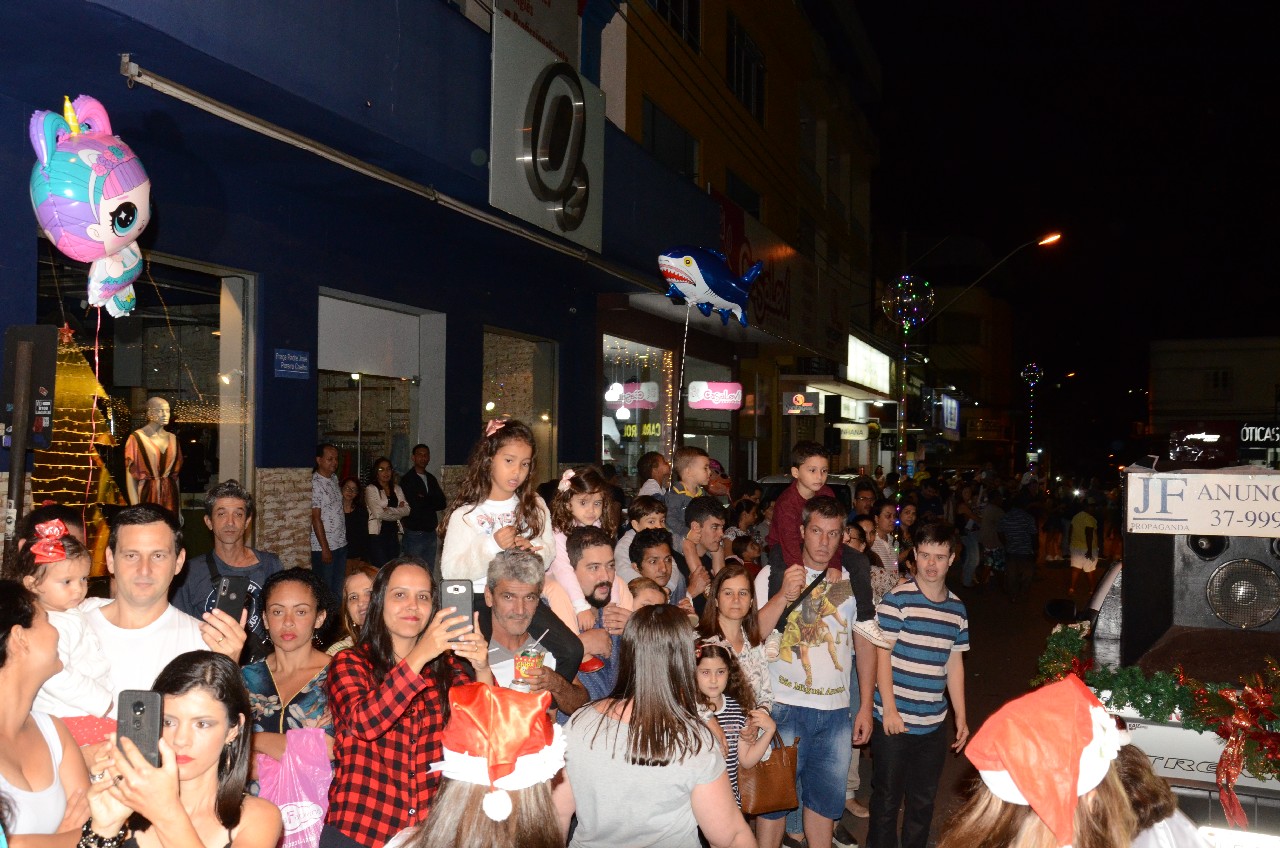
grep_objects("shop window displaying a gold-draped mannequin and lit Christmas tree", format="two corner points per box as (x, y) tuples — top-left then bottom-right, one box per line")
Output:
(31, 240), (252, 569)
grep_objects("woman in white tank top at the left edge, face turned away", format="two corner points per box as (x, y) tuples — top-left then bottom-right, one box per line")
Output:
(0, 580), (88, 848)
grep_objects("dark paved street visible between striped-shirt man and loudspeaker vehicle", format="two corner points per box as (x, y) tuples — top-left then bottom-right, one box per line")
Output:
(841, 562), (1083, 848)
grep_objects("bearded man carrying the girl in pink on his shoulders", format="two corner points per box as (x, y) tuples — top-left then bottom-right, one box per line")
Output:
(564, 526), (631, 701)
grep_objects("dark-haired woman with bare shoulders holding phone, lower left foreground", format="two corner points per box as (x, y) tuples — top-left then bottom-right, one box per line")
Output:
(87, 651), (280, 848)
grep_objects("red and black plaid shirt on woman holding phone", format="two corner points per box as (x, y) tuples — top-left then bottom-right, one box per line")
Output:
(325, 648), (471, 848)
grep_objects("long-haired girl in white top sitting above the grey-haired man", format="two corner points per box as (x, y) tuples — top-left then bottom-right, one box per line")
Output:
(440, 419), (577, 633)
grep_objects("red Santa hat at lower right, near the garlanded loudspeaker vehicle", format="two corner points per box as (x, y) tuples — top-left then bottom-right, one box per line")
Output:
(965, 675), (1120, 845)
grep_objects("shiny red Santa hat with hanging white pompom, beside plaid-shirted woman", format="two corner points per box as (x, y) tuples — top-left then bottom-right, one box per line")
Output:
(431, 683), (564, 821)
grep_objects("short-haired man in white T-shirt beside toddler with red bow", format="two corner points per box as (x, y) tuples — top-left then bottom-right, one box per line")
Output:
(82, 503), (247, 715)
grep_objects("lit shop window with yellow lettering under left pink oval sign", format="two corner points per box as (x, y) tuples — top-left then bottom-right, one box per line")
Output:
(600, 336), (675, 489)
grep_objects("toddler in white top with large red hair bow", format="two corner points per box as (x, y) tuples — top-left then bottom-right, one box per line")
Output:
(15, 519), (114, 744)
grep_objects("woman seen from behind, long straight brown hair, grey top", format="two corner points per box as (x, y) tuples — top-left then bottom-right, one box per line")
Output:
(552, 605), (755, 848)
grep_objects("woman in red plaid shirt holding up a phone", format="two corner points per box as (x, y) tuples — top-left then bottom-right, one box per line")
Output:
(320, 556), (493, 848)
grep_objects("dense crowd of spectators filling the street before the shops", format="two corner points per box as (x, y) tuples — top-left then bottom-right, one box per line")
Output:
(0, 420), (1198, 848)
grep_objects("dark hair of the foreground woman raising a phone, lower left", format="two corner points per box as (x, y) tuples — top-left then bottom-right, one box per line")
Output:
(151, 651), (253, 830)
